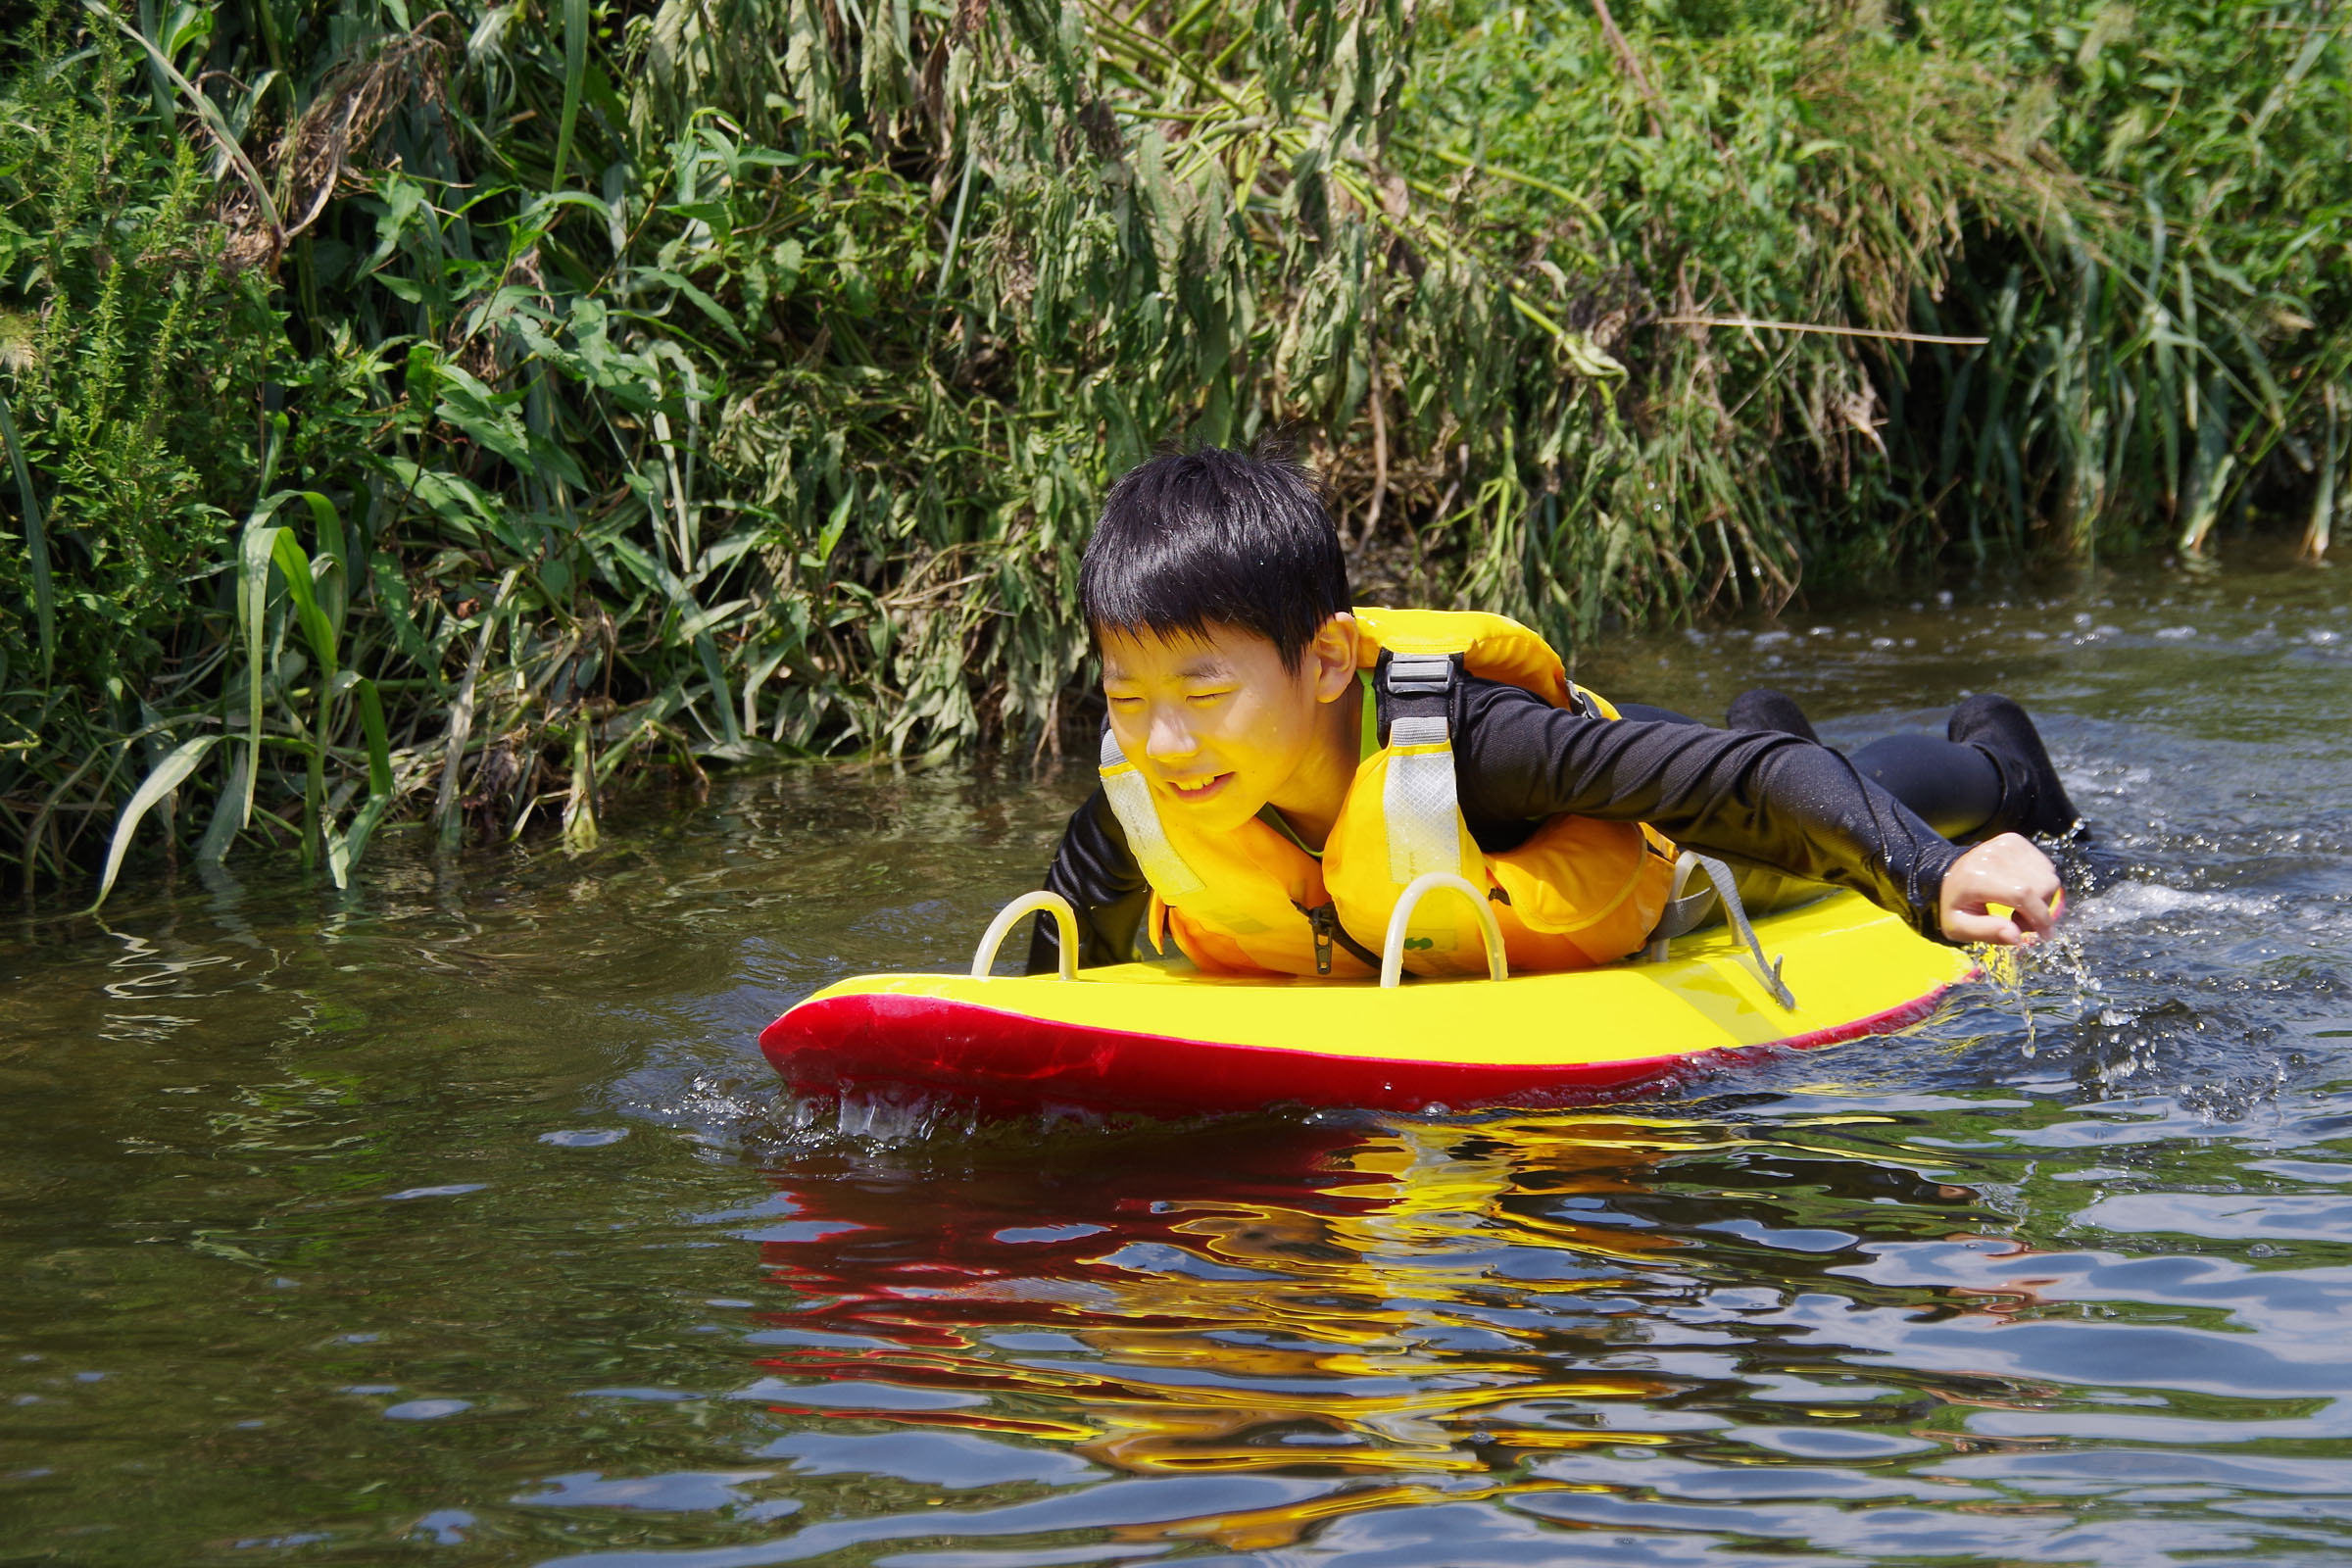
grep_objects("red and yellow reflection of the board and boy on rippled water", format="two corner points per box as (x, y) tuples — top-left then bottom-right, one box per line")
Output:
(733, 1121), (1689, 1469)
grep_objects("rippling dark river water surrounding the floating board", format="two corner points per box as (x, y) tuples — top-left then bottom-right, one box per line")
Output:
(14, 545), (2352, 1568)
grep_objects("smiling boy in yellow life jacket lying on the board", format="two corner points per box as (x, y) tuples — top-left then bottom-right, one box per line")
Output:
(1028, 449), (2075, 976)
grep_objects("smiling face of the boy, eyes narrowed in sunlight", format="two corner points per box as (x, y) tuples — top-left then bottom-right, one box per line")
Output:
(1101, 615), (1354, 832)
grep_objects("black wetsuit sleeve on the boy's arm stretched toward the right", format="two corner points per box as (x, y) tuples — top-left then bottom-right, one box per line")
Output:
(1453, 677), (1962, 941)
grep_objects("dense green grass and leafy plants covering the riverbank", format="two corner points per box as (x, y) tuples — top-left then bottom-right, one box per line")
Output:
(0, 0), (2352, 894)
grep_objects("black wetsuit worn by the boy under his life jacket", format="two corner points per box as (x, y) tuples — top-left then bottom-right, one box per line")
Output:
(1028, 674), (2001, 973)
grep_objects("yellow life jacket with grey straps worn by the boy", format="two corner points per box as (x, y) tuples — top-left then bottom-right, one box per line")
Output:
(1101, 609), (1675, 976)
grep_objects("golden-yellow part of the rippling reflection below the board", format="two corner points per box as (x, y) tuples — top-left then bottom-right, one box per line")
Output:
(753, 1116), (1736, 1476)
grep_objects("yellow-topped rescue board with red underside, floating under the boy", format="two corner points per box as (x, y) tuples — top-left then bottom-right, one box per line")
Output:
(760, 894), (1974, 1109)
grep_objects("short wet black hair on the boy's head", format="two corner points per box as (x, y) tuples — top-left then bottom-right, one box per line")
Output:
(1077, 442), (1352, 672)
